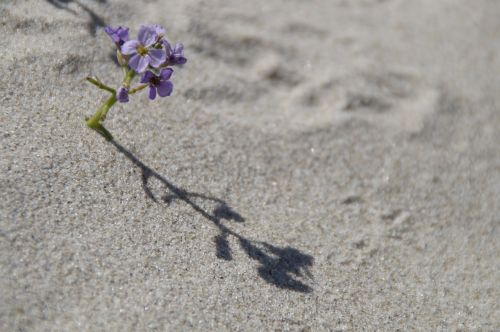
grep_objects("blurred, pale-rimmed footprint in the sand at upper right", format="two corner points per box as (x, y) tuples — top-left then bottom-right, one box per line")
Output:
(290, 70), (441, 133)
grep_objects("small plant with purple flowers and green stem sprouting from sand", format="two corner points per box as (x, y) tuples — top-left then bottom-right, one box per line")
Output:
(86, 25), (187, 140)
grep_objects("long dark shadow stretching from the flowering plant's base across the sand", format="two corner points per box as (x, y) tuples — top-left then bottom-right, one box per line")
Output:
(109, 140), (314, 293)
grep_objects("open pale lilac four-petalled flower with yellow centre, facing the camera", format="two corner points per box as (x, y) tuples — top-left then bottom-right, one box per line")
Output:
(121, 25), (167, 73)
